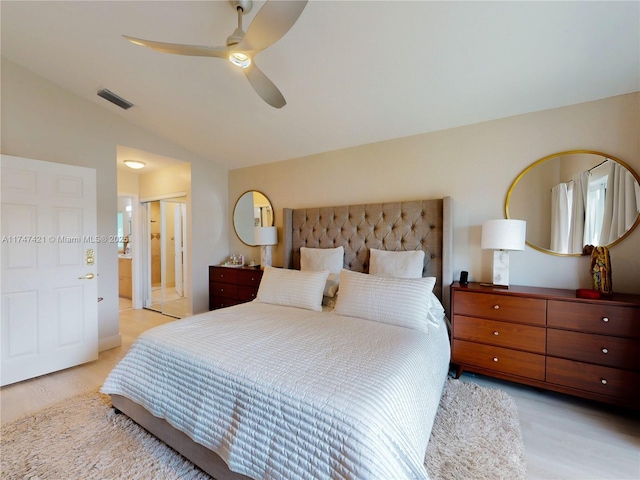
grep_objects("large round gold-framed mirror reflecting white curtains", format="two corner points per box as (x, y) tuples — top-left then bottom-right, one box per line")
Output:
(505, 150), (640, 256)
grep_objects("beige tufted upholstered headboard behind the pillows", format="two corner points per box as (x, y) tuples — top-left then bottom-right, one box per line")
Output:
(283, 197), (453, 313)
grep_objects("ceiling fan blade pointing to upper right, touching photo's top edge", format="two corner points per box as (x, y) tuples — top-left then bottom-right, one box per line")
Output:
(236, 0), (307, 51)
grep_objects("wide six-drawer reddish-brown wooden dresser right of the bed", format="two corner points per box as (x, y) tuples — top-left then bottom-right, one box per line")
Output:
(451, 282), (640, 408)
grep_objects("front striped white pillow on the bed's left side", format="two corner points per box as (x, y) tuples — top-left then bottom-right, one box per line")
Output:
(256, 267), (329, 311)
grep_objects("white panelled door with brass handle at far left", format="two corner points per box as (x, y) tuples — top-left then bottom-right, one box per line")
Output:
(0, 155), (99, 385)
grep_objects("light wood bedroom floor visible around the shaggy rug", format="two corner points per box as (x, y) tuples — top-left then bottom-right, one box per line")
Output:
(0, 310), (640, 480)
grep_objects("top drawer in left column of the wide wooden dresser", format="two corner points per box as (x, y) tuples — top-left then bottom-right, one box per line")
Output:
(453, 290), (547, 325)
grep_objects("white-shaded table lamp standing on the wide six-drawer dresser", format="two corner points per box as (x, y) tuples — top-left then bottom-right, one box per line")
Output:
(482, 219), (527, 288)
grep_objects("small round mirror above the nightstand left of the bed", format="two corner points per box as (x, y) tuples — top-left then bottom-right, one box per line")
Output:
(233, 190), (273, 247)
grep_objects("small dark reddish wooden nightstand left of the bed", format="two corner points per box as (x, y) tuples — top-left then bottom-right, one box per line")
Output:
(209, 265), (262, 310)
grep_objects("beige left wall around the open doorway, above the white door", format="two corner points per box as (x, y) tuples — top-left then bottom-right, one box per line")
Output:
(1, 58), (229, 349)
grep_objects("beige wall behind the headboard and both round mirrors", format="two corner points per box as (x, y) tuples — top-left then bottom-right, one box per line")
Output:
(229, 93), (640, 293)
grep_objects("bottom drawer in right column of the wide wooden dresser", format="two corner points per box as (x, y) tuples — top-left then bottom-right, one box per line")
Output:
(547, 357), (640, 405)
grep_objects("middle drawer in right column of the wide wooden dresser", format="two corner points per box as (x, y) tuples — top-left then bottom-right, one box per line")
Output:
(547, 328), (640, 371)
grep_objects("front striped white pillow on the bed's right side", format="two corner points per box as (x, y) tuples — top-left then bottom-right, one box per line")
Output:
(334, 270), (436, 333)
